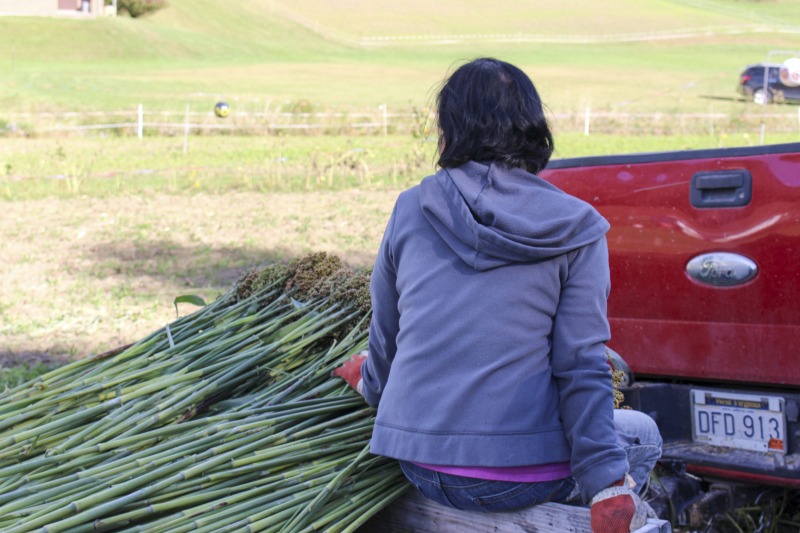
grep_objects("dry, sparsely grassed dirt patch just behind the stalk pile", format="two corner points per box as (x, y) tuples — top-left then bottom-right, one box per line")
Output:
(0, 191), (398, 364)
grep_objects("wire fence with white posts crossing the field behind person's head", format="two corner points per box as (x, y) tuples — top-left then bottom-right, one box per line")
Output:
(0, 105), (800, 138)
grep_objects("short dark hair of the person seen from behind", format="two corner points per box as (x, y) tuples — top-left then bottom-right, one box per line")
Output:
(436, 58), (553, 174)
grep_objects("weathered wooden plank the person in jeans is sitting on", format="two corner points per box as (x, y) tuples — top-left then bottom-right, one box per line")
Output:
(366, 490), (672, 533)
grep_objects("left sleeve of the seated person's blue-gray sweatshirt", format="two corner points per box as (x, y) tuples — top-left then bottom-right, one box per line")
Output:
(361, 206), (400, 407)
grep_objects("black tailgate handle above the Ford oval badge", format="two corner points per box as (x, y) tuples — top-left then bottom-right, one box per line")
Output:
(689, 169), (753, 209)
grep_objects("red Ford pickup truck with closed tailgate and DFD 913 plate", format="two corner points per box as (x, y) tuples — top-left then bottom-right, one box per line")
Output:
(542, 143), (800, 516)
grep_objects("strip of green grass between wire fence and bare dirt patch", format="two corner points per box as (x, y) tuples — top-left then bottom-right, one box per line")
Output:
(6, 130), (800, 201)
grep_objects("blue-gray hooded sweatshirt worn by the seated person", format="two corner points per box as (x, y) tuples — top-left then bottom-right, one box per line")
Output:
(362, 162), (628, 501)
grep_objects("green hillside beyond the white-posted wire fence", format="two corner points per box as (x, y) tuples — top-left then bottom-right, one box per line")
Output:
(0, 0), (800, 114)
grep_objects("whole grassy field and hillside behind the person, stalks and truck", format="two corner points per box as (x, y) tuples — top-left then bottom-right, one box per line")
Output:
(0, 0), (800, 357)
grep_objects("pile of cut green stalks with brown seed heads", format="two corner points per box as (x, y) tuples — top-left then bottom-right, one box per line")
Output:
(0, 254), (408, 533)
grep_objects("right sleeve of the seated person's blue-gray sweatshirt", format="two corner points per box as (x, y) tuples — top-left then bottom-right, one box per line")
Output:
(552, 237), (628, 502)
